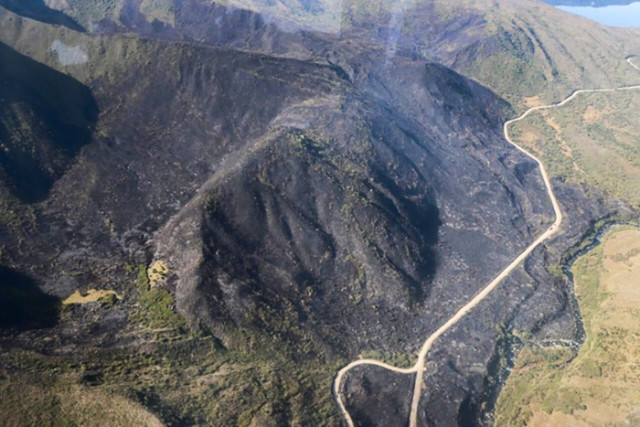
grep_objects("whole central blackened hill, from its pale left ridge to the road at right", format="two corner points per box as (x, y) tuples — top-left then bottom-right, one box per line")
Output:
(149, 50), (547, 370)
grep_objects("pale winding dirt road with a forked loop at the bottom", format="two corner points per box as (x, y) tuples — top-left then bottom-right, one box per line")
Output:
(333, 57), (640, 427)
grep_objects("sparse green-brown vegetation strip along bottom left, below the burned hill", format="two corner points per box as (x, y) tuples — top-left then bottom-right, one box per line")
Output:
(0, 324), (342, 425)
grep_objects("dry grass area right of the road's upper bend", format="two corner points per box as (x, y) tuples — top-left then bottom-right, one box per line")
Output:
(513, 91), (640, 206)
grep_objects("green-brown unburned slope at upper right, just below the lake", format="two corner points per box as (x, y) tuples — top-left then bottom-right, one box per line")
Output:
(428, 1), (640, 103)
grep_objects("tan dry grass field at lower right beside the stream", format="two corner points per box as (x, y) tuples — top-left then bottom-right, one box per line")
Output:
(496, 227), (640, 426)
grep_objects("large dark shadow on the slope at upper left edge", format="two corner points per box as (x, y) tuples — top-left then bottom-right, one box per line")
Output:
(0, 43), (98, 203)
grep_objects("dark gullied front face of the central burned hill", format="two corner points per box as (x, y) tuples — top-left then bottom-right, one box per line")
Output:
(195, 117), (440, 356)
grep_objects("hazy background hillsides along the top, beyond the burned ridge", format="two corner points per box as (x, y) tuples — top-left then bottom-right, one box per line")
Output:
(36, 0), (640, 108)
